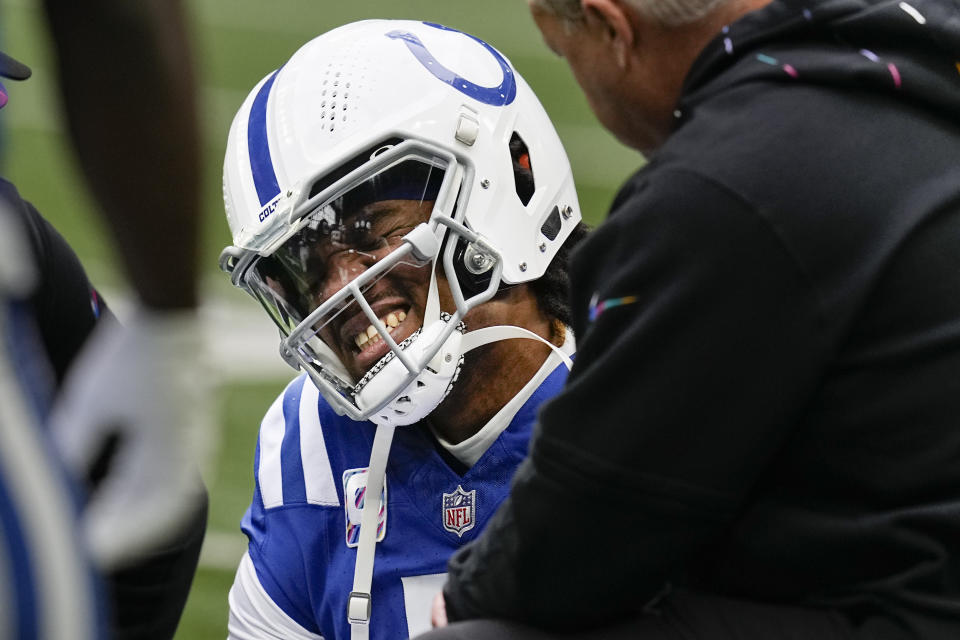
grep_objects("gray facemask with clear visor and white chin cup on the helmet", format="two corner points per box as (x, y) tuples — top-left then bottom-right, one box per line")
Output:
(221, 140), (500, 425)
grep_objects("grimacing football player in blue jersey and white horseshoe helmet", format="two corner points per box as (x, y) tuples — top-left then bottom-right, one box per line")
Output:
(221, 20), (584, 639)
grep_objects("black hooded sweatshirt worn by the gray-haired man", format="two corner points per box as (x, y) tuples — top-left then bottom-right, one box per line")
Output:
(444, 0), (960, 640)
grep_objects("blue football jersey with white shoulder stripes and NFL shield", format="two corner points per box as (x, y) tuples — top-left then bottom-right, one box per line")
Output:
(241, 365), (567, 640)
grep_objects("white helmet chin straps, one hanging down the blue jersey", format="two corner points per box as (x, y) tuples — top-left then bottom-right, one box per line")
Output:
(344, 320), (573, 640)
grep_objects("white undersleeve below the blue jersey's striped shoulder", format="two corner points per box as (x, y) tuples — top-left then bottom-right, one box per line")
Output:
(227, 553), (323, 640)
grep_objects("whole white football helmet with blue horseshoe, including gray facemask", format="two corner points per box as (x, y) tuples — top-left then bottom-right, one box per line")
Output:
(220, 20), (581, 425)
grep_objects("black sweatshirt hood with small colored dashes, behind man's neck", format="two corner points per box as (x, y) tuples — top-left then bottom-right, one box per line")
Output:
(678, 0), (960, 120)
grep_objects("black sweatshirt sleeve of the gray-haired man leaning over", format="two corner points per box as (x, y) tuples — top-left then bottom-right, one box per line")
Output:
(444, 166), (830, 628)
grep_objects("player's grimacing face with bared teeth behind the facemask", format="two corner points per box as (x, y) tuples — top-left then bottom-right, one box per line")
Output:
(311, 200), (445, 379)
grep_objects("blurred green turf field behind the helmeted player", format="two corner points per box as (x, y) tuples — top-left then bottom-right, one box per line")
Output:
(0, 0), (641, 640)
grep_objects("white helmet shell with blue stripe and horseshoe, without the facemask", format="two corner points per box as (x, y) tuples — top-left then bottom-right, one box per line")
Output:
(223, 20), (581, 284)
